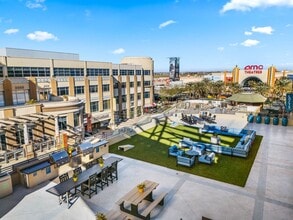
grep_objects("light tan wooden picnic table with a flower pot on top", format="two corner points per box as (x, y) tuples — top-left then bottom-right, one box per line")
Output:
(116, 180), (159, 218)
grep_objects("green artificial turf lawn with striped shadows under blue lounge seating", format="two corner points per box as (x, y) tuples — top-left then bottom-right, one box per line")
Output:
(109, 123), (262, 187)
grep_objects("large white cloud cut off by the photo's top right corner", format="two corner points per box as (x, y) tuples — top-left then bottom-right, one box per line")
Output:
(220, 0), (293, 13)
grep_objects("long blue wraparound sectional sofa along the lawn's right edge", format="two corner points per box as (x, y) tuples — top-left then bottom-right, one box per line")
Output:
(179, 126), (256, 157)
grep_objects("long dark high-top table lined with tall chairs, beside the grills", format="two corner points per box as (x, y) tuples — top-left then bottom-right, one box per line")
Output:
(46, 156), (122, 208)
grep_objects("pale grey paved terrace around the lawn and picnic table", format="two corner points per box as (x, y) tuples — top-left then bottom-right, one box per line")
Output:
(0, 124), (293, 220)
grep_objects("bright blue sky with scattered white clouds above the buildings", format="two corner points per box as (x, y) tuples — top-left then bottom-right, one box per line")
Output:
(0, 0), (293, 72)
